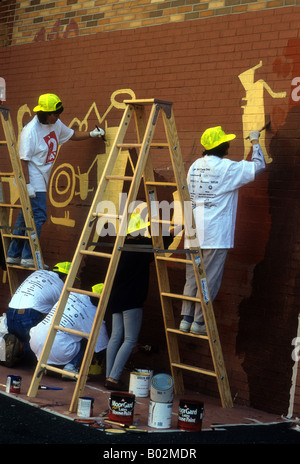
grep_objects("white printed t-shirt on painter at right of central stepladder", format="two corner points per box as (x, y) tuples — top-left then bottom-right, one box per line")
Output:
(185, 149), (265, 249)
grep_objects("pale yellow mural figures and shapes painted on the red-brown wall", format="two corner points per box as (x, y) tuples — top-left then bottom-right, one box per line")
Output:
(0, 54), (287, 284)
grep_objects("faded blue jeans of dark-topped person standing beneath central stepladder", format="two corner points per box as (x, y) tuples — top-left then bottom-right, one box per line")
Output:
(106, 308), (143, 380)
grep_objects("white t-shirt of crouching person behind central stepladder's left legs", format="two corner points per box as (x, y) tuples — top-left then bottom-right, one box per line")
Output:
(30, 293), (109, 365)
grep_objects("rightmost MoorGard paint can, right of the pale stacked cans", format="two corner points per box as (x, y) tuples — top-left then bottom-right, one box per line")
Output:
(177, 399), (204, 432)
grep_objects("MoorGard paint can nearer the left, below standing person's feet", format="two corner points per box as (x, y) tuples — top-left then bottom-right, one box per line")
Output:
(108, 392), (135, 425)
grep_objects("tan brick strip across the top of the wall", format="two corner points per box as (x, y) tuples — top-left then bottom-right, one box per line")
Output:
(0, 0), (298, 46)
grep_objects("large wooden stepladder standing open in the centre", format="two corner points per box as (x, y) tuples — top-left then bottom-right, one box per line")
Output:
(28, 99), (232, 412)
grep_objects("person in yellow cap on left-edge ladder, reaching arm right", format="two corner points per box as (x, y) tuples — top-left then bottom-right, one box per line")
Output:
(6, 93), (105, 267)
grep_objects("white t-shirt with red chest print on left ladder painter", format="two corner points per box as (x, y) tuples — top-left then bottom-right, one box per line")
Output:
(19, 116), (74, 192)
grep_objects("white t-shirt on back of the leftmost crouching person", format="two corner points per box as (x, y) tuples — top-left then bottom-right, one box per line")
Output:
(9, 270), (64, 314)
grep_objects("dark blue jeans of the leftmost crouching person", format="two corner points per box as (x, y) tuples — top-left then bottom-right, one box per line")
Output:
(6, 308), (45, 358)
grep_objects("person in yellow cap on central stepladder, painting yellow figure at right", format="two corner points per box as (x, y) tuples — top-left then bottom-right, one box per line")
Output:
(179, 126), (266, 335)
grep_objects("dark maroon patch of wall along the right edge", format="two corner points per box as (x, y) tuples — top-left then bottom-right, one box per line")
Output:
(236, 106), (300, 414)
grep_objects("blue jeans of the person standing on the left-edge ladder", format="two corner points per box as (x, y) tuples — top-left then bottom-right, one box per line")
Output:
(7, 192), (47, 259)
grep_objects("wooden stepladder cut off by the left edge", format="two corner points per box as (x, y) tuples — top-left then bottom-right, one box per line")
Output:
(0, 105), (44, 294)
